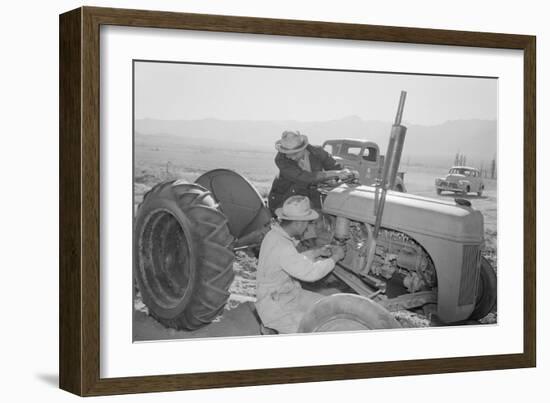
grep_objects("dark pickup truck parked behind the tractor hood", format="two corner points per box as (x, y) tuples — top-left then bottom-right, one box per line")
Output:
(323, 139), (407, 192)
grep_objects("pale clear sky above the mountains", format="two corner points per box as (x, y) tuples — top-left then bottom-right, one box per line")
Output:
(135, 62), (498, 125)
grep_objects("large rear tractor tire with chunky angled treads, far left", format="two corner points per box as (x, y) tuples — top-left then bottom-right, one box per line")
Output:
(134, 181), (235, 330)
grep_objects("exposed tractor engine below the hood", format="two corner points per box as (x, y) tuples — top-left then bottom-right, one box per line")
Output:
(334, 217), (437, 294)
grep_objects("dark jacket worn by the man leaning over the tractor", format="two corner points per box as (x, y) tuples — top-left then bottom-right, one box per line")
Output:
(268, 144), (342, 213)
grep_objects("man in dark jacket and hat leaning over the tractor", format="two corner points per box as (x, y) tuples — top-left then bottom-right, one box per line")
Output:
(268, 131), (350, 214)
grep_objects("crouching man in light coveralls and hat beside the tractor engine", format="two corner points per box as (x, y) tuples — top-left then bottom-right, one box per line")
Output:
(256, 196), (345, 333)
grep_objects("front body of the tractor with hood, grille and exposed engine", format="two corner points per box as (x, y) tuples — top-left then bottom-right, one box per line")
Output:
(323, 185), (483, 323)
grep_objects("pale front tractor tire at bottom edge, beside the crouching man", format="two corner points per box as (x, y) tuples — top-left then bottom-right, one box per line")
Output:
(298, 294), (401, 333)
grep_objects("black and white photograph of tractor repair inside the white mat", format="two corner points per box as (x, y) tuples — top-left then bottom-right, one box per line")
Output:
(134, 60), (499, 342)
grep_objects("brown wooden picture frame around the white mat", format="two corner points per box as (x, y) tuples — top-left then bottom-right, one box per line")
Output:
(59, 7), (536, 396)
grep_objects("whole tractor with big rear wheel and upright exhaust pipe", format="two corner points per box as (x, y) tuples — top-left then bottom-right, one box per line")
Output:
(134, 92), (496, 332)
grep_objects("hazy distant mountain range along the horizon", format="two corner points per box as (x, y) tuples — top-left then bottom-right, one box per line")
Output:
(135, 116), (497, 166)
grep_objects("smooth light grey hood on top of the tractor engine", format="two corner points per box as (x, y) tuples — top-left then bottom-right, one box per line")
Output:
(323, 185), (483, 243)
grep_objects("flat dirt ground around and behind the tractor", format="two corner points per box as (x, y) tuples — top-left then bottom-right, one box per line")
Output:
(133, 144), (497, 341)
